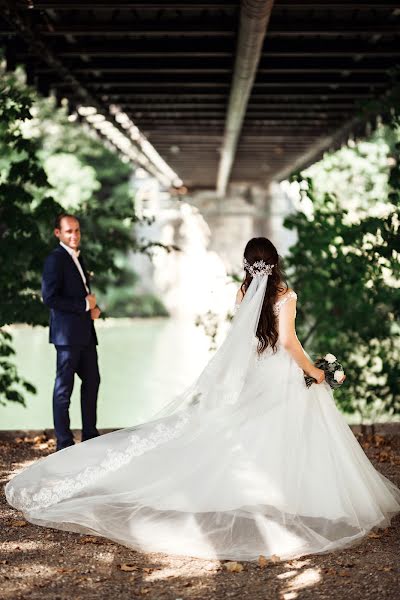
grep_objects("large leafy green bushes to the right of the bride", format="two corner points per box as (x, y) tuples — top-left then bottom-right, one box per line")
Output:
(196, 116), (400, 422)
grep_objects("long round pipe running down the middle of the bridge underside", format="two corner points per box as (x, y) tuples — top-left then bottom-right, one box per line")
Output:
(217, 0), (274, 197)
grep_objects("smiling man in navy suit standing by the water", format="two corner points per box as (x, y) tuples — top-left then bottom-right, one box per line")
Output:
(42, 214), (100, 450)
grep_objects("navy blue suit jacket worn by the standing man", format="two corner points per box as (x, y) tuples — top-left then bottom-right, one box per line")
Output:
(42, 245), (97, 346)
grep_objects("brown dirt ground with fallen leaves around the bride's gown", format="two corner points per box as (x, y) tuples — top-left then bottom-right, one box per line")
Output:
(0, 424), (400, 600)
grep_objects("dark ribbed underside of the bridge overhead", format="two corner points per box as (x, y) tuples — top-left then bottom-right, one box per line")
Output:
(0, 0), (400, 197)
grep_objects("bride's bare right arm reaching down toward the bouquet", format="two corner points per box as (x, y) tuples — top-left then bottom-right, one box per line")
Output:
(278, 298), (323, 382)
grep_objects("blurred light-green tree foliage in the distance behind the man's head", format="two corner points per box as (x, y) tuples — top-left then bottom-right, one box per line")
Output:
(27, 93), (147, 296)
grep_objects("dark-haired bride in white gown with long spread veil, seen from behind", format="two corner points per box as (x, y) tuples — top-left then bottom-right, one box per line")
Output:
(5, 238), (400, 561)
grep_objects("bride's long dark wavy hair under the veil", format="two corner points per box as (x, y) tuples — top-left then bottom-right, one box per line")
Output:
(240, 237), (288, 354)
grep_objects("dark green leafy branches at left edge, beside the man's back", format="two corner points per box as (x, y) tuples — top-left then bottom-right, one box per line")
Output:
(0, 71), (61, 404)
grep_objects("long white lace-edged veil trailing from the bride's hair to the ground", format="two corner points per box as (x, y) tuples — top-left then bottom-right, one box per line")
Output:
(5, 275), (268, 513)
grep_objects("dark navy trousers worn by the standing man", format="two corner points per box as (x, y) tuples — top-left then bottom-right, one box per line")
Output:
(53, 340), (100, 450)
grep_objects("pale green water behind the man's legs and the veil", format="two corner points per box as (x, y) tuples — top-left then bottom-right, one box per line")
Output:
(0, 319), (210, 429)
